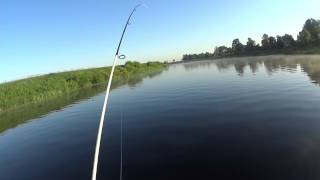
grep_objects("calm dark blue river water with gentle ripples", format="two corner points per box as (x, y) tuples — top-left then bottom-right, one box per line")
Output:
(0, 56), (320, 180)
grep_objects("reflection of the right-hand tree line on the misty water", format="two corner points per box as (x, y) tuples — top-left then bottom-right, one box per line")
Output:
(184, 55), (320, 84)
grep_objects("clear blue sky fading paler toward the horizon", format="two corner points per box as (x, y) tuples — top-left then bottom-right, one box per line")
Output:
(0, 0), (320, 83)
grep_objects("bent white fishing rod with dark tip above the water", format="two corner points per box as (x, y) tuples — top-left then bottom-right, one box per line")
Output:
(91, 4), (141, 180)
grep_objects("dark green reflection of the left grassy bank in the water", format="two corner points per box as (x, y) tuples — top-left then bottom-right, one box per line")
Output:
(0, 70), (162, 133)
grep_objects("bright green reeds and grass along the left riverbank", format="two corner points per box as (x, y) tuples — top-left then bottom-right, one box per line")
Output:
(0, 61), (167, 113)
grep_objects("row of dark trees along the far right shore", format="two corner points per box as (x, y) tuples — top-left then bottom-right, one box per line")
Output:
(182, 19), (320, 61)
